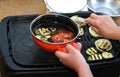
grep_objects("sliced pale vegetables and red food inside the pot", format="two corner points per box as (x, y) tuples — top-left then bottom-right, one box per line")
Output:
(35, 27), (74, 43)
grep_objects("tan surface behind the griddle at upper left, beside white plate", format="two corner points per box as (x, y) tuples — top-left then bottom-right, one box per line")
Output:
(0, 0), (46, 20)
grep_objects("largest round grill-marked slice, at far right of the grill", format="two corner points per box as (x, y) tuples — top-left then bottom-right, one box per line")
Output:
(95, 39), (112, 52)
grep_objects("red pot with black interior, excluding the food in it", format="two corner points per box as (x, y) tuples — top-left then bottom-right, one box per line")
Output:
(30, 14), (79, 52)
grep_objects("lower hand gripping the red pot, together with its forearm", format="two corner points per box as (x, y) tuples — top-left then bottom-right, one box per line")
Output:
(55, 43), (92, 77)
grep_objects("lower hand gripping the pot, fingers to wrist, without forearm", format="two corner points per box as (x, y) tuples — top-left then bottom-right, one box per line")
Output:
(55, 43), (86, 71)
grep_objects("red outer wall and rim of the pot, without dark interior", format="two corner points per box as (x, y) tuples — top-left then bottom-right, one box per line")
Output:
(30, 14), (79, 52)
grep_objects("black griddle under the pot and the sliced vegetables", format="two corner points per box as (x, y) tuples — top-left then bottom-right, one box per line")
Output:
(0, 12), (120, 77)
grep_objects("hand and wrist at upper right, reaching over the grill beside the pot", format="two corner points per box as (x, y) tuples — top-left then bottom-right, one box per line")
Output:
(85, 14), (120, 40)
